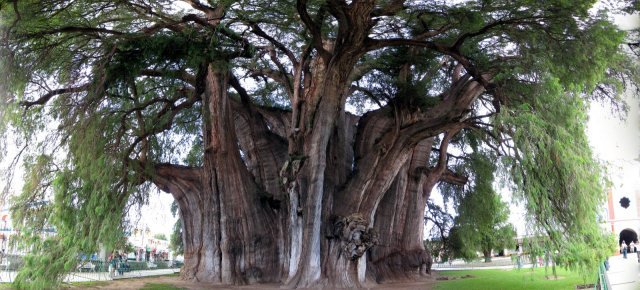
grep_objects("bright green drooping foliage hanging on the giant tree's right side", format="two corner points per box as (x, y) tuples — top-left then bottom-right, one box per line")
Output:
(498, 78), (611, 276)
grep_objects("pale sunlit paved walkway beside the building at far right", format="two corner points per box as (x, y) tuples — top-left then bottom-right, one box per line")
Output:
(607, 253), (640, 290)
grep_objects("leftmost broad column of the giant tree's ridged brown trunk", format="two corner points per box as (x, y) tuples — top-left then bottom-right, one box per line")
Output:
(154, 66), (285, 284)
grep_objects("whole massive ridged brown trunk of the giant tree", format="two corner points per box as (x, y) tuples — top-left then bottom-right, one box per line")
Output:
(142, 1), (490, 288)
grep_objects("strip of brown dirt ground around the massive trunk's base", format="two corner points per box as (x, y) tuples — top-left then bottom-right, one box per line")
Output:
(71, 276), (436, 290)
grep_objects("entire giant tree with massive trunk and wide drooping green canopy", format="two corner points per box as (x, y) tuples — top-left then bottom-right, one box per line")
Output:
(0, 0), (635, 287)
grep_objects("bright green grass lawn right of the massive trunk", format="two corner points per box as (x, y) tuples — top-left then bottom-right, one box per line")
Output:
(435, 268), (596, 290)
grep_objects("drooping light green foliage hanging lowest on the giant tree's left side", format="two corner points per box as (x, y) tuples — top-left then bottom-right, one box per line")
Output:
(12, 119), (129, 289)
